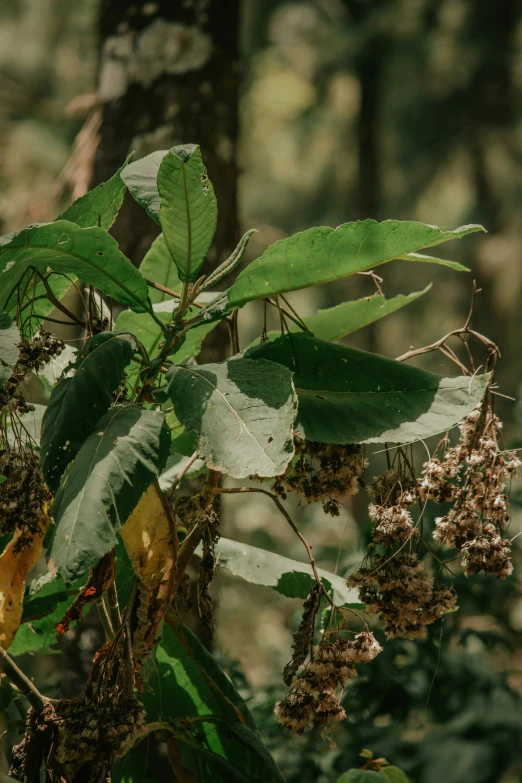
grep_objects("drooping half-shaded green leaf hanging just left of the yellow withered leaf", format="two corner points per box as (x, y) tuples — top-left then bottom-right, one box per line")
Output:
(50, 405), (170, 583)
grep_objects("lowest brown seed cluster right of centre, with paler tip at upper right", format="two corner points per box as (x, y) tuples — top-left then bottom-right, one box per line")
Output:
(275, 631), (382, 734)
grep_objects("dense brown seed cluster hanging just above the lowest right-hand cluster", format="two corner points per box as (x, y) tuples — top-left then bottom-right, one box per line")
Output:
(348, 553), (457, 639)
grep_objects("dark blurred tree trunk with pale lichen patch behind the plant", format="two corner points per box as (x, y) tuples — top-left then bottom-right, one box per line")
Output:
(93, 0), (239, 263)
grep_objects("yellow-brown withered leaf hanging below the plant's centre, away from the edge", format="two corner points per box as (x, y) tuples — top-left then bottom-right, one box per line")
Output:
(121, 484), (177, 669)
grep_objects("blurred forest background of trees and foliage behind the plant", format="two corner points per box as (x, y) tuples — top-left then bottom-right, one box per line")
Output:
(0, 0), (522, 783)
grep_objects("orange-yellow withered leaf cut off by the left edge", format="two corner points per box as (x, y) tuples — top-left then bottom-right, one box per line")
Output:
(0, 503), (51, 650)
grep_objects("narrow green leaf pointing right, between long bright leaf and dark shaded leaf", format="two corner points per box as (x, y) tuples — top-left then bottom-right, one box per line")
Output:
(249, 290), (431, 348)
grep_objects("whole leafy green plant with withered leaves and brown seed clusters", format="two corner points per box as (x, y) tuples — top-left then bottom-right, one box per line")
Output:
(0, 145), (519, 783)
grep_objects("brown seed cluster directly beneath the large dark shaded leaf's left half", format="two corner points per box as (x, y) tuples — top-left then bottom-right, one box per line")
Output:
(273, 438), (368, 516)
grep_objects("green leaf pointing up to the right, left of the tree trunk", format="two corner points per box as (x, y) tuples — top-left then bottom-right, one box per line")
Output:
(56, 164), (127, 231)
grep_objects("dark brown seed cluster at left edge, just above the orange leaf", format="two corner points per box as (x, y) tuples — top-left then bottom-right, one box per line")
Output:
(0, 451), (51, 551)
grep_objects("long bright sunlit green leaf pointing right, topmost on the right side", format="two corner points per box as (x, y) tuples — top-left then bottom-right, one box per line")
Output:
(228, 220), (484, 308)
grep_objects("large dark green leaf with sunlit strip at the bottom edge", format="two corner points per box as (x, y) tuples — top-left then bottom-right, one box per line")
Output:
(142, 624), (283, 783)
